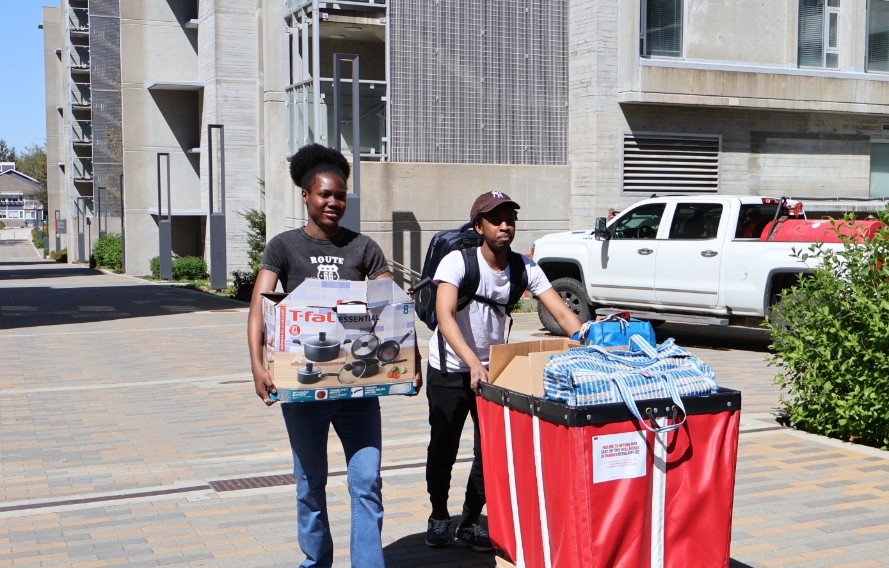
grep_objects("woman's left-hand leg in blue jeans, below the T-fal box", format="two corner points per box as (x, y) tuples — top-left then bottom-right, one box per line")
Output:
(281, 401), (336, 568)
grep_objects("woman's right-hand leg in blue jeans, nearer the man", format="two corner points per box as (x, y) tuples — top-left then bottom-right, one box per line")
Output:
(333, 398), (385, 568)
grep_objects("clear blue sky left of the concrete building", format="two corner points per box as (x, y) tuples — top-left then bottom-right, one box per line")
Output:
(0, 0), (49, 150)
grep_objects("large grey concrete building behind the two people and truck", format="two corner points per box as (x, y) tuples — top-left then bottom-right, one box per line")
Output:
(44, 0), (889, 280)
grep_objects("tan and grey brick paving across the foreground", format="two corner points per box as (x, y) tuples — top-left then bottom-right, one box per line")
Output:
(0, 231), (889, 568)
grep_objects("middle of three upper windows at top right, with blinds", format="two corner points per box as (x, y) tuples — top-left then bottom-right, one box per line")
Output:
(797, 0), (840, 69)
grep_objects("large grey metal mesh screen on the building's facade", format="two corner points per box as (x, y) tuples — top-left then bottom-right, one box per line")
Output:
(389, 0), (568, 164)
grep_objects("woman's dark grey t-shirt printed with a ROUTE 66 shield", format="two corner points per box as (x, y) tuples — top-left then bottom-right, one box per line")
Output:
(259, 227), (389, 294)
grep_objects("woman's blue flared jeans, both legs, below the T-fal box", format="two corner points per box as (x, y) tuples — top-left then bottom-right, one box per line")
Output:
(281, 398), (385, 568)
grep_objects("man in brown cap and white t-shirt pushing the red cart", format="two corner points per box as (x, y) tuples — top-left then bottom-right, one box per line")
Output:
(424, 191), (581, 552)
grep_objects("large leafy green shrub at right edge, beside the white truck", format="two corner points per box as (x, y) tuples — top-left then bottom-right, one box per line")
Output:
(766, 207), (889, 449)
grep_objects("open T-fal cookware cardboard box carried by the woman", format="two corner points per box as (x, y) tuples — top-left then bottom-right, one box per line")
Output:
(262, 278), (417, 402)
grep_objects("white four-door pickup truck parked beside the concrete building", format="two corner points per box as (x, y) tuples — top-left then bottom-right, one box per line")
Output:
(532, 195), (882, 333)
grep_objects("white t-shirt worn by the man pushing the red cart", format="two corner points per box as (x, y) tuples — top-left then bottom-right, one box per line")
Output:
(429, 247), (552, 371)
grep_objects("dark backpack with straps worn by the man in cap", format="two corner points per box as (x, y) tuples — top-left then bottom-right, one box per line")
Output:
(408, 223), (528, 330)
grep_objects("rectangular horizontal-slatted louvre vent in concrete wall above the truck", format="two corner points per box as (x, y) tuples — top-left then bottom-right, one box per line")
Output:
(621, 132), (722, 194)
